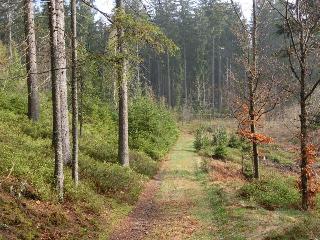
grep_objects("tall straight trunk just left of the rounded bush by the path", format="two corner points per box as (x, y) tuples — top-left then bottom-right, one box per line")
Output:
(116, 0), (129, 166)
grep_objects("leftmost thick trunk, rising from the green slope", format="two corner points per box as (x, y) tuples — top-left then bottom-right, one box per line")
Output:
(24, 0), (40, 121)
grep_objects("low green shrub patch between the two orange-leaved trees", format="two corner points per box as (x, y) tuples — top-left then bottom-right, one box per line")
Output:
(240, 175), (300, 210)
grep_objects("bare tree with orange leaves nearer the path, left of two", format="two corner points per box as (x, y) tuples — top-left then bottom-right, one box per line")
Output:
(231, 0), (282, 179)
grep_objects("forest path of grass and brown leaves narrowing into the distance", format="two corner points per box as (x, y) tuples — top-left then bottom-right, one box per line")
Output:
(109, 133), (213, 240)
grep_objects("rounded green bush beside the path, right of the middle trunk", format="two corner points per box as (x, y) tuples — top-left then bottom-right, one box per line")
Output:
(129, 97), (178, 159)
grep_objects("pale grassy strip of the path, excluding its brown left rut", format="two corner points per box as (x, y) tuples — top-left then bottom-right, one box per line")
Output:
(145, 133), (214, 240)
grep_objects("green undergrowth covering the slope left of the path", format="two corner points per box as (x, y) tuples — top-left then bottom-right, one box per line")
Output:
(0, 92), (178, 205)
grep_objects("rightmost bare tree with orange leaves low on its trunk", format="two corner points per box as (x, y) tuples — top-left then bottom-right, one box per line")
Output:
(269, 0), (320, 210)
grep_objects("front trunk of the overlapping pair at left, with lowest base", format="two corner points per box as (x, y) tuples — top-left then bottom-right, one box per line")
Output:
(48, 0), (64, 200)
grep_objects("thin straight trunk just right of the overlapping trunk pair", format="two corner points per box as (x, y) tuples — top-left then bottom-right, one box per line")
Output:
(71, 0), (79, 186)
